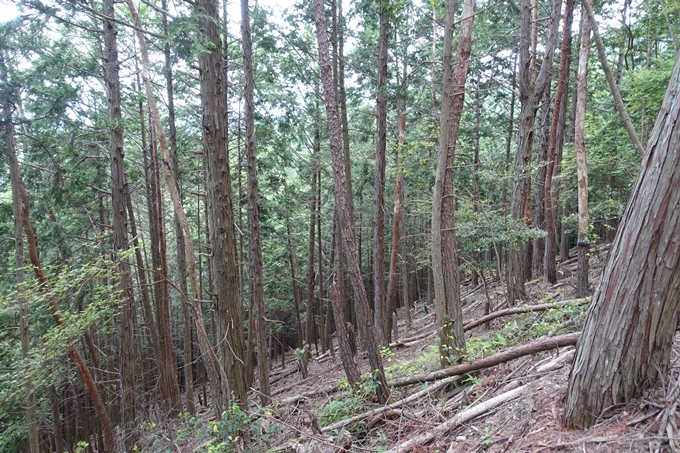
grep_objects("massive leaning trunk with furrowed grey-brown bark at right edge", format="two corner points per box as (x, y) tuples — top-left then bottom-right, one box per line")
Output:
(565, 54), (680, 428)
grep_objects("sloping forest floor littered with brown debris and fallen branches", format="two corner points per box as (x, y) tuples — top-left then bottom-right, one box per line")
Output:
(151, 247), (680, 453)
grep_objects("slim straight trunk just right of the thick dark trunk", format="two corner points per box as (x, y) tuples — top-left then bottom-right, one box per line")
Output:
(240, 0), (271, 406)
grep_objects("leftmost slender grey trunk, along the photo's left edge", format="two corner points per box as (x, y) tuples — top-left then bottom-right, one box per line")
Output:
(0, 69), (40, 453)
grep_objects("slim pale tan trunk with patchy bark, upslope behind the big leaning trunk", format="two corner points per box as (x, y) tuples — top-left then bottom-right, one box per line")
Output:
(574, 11), (590, 297)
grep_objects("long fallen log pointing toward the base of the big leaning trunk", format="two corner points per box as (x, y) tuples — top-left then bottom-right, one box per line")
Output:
(387, 332), (581, 387)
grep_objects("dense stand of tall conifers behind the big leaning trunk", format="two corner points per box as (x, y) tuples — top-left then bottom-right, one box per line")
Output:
(0, 0), (680, 453)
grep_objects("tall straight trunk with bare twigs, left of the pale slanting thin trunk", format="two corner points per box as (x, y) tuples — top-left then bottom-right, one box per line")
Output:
(102, 0), (137, 442)
